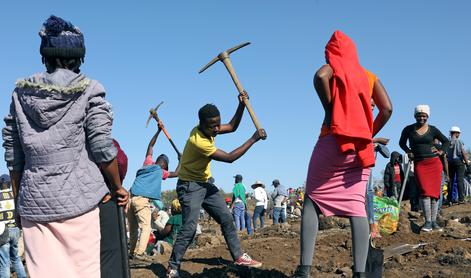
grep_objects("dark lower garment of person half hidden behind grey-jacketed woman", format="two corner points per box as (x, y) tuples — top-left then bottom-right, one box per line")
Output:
(98, 199), (127, 278)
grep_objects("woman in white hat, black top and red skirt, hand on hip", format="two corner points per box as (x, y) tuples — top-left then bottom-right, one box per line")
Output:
(399, 105), (449, 232)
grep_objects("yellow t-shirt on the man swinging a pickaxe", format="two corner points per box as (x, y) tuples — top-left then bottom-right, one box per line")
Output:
(178, 126), (217, 182)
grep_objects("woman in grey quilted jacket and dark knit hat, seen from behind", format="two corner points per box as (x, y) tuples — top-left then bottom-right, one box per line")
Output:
(2, 16), (128, 277)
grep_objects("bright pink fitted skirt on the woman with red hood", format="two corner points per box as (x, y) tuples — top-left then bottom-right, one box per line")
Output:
(306, 135), (371, 217)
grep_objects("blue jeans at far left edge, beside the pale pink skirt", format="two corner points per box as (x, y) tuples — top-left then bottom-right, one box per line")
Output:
(0, 227), (26, 278)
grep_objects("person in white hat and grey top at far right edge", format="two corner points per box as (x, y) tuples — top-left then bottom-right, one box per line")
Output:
(447, 126), (468, 205)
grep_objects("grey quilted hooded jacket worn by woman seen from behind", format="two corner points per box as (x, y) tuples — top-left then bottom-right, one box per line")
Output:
(2, 69), (117, 222)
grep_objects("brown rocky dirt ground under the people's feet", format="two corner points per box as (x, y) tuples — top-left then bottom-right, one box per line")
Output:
(131, 203), (471, 278)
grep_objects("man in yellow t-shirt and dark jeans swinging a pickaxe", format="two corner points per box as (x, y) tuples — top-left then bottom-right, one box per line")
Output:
(167, 92), (266, 278)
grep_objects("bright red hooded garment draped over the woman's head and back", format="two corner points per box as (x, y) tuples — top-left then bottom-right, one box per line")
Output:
(325, 30), (375, 167)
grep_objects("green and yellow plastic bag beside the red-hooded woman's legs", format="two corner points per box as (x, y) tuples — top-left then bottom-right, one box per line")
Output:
(373, 196), (399, 235)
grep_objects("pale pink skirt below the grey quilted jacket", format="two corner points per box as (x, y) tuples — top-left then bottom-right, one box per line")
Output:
(21, 208), (101, 278)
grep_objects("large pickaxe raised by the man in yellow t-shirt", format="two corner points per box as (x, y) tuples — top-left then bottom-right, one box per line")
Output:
(199, 42), (267, 140)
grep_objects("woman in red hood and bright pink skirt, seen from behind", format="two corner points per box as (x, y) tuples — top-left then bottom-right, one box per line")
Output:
(292, 31), (392, 278)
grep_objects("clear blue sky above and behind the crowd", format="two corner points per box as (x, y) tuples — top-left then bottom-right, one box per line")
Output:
(0, 0), (471, 191)
